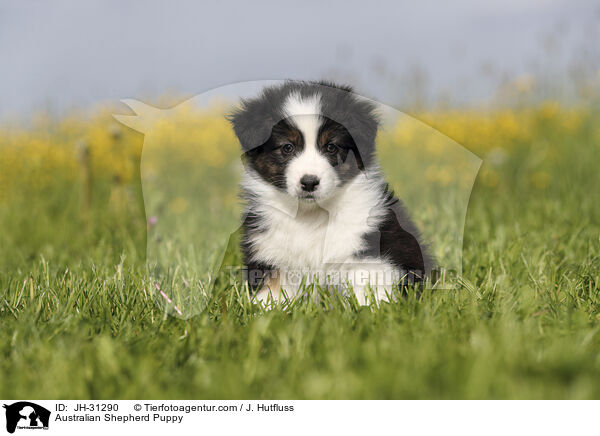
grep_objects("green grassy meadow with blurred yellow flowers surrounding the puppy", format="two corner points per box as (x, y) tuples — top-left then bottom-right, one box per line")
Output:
(0, 101), (600, 399)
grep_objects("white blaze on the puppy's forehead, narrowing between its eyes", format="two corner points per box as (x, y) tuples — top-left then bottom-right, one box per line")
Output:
(283, 92), (322, 149)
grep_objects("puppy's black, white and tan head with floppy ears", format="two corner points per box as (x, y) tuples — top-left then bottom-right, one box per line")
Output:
(230, 82), (377, 202)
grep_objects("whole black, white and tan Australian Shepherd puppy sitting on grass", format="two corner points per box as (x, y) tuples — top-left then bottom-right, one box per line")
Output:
(230, 82), (432, 304)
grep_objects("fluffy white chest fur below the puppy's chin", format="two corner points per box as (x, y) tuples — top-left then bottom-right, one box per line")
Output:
(249, 170), (385, 270)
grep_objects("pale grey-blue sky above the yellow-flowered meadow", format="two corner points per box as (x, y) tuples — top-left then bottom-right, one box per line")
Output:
(0, 0), (600, 119)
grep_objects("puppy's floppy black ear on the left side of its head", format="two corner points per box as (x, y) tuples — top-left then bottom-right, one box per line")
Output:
(227, 100), (275, 152)
